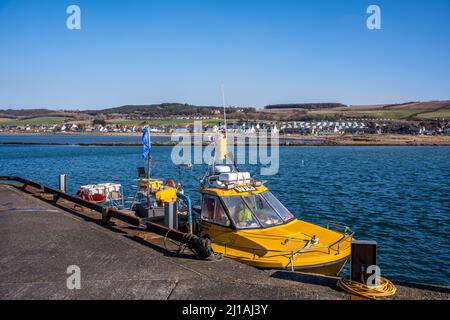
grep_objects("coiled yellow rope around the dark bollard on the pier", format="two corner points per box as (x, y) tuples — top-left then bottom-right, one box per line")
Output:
(337, 277), (397, 300)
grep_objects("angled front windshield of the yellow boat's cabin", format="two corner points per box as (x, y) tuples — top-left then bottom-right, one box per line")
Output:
(222, 191), (294, 229)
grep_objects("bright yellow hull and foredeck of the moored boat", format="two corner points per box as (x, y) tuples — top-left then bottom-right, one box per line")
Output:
(202, 220), (353, 275)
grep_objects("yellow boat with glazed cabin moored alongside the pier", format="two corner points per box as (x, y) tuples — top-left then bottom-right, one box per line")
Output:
(195, 134), (354, 275)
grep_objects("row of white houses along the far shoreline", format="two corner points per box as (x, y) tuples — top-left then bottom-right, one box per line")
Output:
(0, 119), (450, 135)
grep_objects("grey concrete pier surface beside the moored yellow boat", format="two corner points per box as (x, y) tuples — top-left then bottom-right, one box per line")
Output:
(0, 184), (450, 300)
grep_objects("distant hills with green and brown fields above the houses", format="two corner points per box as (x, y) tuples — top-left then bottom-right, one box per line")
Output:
(0, 100), (450, 123)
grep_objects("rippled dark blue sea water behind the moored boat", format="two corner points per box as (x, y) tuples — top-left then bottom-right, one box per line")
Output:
(0, 136), (450, 285)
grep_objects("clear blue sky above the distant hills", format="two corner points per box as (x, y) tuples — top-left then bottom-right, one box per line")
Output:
(0, 0), (450, 109)
